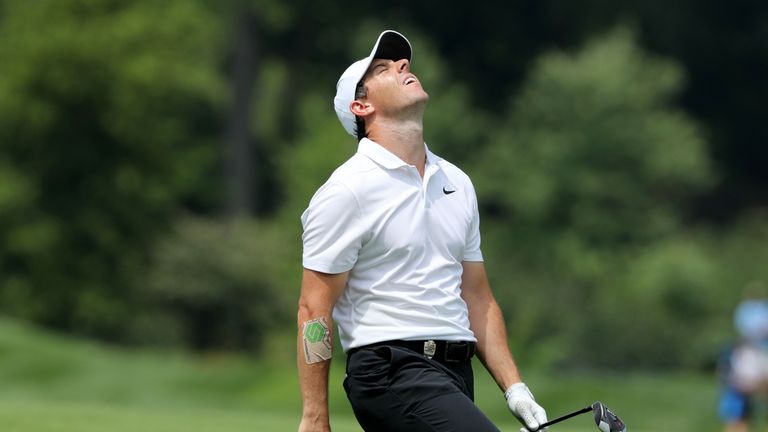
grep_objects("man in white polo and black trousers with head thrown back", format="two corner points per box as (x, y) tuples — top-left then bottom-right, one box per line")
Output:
(298, 30), (546, 432)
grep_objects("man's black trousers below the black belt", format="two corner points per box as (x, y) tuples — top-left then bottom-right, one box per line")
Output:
(344, 346), (499, 432)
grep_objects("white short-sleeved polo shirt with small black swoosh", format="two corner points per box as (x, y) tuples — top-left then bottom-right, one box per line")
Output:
(301, 138), (483, 351)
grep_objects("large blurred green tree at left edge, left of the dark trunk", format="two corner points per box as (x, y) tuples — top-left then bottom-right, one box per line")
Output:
(0, 0), (225, 337)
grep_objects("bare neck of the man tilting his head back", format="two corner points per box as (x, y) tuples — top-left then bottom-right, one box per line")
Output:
(368, 121), (427, 177)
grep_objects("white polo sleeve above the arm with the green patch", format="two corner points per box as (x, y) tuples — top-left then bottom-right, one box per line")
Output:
(301, 182), (363, 274)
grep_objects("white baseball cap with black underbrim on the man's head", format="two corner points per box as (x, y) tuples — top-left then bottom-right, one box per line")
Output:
(333, 30), (413, 138)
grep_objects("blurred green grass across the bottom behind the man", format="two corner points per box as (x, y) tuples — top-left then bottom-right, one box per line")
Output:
(0, 319), (721, 432)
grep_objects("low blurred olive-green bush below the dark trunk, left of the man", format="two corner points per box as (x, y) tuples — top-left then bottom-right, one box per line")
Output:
(132, 217), (298, 351)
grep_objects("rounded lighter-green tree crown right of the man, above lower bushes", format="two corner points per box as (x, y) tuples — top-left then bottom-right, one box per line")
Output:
(475, 29), (712, 248)
